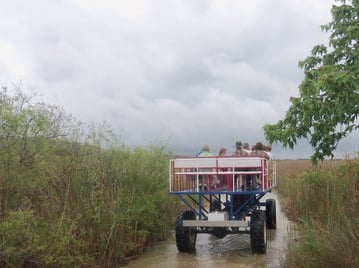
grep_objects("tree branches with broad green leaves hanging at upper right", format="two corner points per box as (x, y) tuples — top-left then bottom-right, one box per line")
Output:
(264, 0), (359, 162)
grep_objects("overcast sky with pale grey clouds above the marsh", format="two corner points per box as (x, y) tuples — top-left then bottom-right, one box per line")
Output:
(0, 0), (353, 157)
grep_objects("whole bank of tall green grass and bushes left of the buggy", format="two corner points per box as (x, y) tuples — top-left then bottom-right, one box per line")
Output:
(0, 87), (178, 267)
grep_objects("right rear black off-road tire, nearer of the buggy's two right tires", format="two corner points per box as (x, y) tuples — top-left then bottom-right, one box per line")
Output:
(250, 210), (267, 254)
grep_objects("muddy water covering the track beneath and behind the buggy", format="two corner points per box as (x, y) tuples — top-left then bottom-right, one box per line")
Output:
(126, 193), (290, 268)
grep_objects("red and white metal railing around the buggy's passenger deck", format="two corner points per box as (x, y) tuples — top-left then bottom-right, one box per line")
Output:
(169, 156), (276, 193)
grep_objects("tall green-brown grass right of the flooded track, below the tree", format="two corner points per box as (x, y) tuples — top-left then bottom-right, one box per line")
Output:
(278, 159), (359, 267)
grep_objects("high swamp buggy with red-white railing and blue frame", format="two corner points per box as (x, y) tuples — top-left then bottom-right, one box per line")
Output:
(169, 156), (277, 254)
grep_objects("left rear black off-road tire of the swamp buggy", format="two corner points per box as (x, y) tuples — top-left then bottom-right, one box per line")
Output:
(176, 210), (197, 253)
